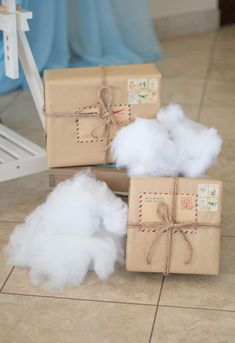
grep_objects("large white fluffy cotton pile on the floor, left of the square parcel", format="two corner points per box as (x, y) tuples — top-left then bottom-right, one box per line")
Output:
(5, 173), (127, 288)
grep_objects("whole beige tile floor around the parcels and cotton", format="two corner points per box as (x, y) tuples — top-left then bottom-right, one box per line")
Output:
(0, 26), (235, 343)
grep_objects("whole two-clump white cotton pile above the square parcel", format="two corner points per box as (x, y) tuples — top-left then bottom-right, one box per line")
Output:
(111, 104), (222, 177)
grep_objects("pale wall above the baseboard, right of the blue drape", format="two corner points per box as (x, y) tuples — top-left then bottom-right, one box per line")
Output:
(149, 0), (218, 18)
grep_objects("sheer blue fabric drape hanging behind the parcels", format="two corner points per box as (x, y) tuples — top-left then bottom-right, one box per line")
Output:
(0, 0), (161, 94)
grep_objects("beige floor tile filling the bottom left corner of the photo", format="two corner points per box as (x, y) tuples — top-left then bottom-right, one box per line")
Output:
(0, 294), (155, 343)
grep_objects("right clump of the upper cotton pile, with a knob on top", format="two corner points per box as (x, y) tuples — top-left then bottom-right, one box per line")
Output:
(157, 104), (222, 177)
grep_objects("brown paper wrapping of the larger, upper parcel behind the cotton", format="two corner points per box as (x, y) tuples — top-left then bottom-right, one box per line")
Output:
(44, 63), (161, 168)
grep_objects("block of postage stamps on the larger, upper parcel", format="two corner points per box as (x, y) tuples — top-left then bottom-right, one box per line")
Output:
(127, 79), (159, 105)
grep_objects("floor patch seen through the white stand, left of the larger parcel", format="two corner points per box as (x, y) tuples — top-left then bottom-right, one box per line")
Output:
(2, 91), (44, 146)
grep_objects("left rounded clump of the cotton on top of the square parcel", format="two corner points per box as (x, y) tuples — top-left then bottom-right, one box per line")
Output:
(111, 118), (178, 176)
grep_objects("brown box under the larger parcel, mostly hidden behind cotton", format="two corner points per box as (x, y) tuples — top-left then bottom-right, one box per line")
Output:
(49, 166), (130, 196)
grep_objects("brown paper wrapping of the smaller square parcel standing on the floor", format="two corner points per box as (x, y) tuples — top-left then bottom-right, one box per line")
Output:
(126, 177), (222, 275)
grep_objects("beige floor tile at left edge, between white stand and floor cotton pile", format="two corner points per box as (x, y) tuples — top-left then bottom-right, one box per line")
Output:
(0, 172), (49, 221)
